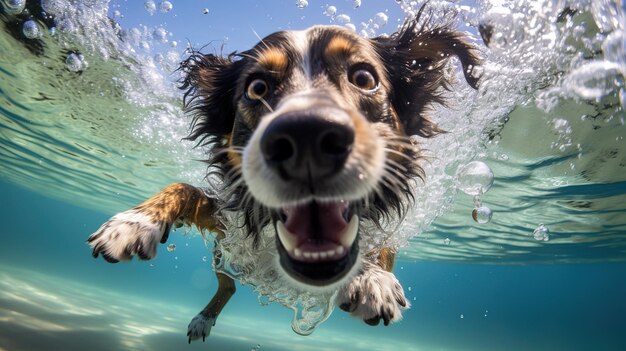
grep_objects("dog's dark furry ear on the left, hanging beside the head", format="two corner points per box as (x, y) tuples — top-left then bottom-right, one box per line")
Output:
(179, 52), (242, 144)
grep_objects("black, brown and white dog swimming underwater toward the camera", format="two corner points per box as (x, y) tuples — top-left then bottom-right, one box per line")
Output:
(87, 8), (480, 342)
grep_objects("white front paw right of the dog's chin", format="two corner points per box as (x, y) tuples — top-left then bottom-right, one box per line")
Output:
(337, 262), (409, 325)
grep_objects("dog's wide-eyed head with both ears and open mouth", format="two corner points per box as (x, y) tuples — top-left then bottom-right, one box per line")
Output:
(183, 16), (477, 286)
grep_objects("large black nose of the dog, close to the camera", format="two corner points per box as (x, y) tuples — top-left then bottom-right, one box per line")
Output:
(261, 109), (354, 185)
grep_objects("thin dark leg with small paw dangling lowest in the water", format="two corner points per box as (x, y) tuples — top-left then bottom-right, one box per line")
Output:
(187, 238), (236, 343)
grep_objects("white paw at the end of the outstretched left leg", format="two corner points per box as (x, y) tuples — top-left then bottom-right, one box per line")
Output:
(87, 209), (170, 263)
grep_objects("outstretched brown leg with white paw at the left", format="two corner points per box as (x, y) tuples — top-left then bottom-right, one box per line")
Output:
(87, 183), (220, 263)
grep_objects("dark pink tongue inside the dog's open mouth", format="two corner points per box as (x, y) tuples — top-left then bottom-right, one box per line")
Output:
(283, 202), (348, 243)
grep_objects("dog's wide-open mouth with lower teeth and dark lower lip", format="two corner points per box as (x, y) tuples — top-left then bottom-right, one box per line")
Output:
(276, 201), (359, 286)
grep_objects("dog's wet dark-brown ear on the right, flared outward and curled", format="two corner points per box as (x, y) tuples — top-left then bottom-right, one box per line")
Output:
(372, 7), (480, 137)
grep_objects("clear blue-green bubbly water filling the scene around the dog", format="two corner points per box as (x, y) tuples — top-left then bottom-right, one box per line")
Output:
(0, 0), (626, 350)
